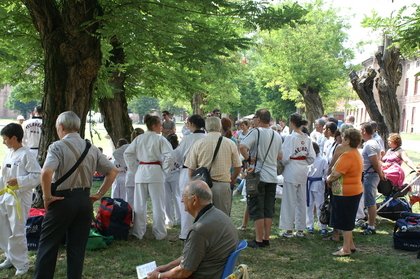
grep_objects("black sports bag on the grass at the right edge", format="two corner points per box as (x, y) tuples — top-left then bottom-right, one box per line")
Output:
(393, 213), (420, 251)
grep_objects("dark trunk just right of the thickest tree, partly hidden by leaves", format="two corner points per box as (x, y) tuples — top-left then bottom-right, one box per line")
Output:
(99, 37), (133, 146)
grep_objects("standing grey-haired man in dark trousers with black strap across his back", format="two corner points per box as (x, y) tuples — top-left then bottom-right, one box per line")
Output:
(34, 111), (118, 279)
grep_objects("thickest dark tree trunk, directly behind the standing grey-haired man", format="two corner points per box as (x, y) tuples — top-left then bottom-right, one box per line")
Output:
(23, 0), (101, 161)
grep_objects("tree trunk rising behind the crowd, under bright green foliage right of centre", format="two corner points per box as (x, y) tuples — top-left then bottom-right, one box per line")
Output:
(299, 85), (324, 131)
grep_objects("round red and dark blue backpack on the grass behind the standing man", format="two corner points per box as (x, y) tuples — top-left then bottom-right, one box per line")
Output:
(95, 197), (133, 240)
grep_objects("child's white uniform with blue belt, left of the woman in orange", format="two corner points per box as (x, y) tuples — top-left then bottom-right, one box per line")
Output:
(306, 154), (328, 229)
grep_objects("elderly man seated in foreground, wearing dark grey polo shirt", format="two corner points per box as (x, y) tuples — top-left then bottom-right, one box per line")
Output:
(147, 180), (238, 279)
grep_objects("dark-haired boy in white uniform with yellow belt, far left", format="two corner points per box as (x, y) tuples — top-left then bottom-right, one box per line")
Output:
(0, 123), (41, 276)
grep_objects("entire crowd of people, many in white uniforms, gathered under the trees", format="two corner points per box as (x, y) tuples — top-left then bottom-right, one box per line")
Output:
(0, 107), (418, 278)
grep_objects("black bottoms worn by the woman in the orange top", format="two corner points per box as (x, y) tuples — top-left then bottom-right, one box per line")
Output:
(331, 194), (362, 231)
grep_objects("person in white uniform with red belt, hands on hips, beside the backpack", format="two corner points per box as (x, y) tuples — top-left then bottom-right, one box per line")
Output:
(124, 114), (173, 240)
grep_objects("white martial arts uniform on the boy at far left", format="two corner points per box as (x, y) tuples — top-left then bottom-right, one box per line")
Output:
(0, 147), (41, 270)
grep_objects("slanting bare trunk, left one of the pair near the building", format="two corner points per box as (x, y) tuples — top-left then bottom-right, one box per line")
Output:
(350, 68), (388, 145)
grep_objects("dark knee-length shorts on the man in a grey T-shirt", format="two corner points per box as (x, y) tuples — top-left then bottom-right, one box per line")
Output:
(248, 182), (277, 221)
